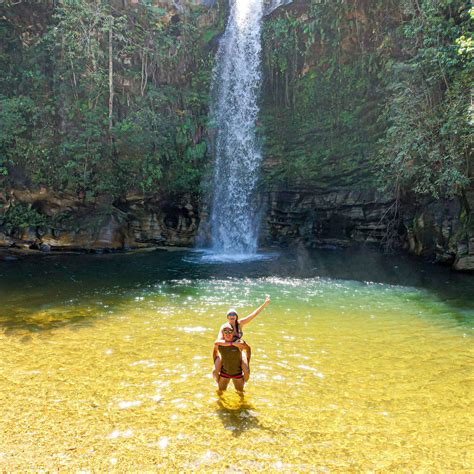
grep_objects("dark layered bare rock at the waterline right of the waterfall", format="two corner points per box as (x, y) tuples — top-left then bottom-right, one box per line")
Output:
(260, 189), (474, 271)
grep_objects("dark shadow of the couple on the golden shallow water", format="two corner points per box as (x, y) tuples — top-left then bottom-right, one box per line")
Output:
(216, 392), (274, 438)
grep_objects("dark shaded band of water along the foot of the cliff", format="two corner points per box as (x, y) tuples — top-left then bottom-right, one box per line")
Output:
(0, 246), (474, 288)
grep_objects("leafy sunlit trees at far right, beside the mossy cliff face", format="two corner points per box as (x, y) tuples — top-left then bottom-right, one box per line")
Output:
(379, 0), (474, 198)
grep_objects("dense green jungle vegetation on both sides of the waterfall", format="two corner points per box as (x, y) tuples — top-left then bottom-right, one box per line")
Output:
(0, 0), (474, 230)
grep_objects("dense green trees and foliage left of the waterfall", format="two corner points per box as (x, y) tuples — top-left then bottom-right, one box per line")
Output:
(0, 0), (218, 207)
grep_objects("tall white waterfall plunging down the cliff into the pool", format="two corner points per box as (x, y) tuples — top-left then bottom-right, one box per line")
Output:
(210, 0), (263, 256)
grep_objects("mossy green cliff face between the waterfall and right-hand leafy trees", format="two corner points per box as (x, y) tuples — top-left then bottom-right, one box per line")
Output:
(261, 1), (387, 188)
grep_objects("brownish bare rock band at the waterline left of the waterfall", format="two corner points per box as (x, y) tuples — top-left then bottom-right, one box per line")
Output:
(0, 195), (197, 252)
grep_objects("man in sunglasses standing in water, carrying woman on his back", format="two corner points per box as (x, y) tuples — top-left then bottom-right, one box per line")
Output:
(215, 323), (245, 395)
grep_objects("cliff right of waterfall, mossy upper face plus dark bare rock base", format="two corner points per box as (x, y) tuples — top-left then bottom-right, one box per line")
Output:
(260, 0), (474, 271)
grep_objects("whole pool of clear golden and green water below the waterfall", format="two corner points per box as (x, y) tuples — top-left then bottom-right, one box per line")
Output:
(0, 251), (474, 472)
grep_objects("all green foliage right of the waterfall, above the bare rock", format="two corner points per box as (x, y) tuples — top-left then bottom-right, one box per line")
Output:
(260, 0), (474, 197)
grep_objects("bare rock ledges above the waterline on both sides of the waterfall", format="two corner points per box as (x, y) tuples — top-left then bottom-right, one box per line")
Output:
(0, 188), (474, 272)
